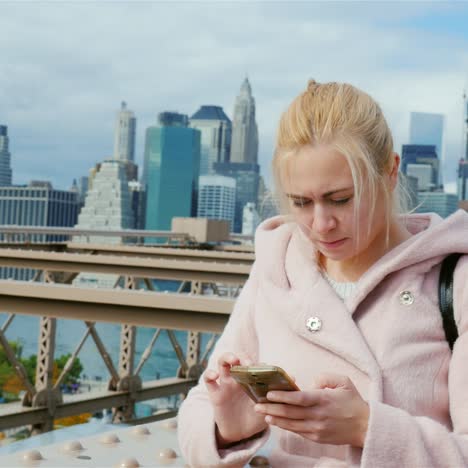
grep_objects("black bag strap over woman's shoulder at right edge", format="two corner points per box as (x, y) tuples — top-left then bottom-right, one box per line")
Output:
(439, 253), (462, 350)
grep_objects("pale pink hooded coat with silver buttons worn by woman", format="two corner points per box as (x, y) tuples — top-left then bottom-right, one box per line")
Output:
(179, 211), (468, 468)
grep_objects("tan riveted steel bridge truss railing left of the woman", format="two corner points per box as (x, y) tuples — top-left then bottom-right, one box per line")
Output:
(0, 246), (252, 432)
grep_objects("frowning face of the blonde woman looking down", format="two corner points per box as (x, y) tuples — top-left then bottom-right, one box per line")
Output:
(283, 145), (386, 261)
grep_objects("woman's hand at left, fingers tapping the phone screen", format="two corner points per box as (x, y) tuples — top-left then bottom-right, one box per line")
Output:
(203, 353), (268, 448)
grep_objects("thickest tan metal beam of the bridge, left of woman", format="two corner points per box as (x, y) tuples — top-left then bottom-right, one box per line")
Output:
(0, 280), (234, 333)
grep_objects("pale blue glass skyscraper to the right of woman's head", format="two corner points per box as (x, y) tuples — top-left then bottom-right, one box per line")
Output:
(410, 112), (444, 185)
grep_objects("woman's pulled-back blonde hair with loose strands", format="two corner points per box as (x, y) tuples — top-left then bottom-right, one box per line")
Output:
(273, 80), (406, 242)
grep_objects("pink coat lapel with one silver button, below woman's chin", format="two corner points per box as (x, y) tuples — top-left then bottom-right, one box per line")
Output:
(260, 229), (381, 393)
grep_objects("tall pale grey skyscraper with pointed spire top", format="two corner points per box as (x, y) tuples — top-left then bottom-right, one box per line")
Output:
(230, 78), (258, 164)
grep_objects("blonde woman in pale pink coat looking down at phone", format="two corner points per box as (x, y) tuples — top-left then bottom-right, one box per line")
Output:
(179, 81), (468, 468)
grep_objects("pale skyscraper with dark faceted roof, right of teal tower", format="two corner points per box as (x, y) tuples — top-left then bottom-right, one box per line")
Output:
(189, 106), (232, 175)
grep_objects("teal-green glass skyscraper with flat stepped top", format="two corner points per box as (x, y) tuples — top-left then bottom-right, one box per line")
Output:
(143, 112), (200, 231)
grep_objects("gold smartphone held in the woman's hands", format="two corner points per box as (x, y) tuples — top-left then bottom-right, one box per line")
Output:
(231, 365), (299, 403)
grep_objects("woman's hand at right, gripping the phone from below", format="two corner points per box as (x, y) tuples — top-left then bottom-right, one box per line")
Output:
(255, 374), (369, 447)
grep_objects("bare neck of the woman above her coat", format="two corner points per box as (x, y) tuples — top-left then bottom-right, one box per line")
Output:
(320, 220), (411, 283)
